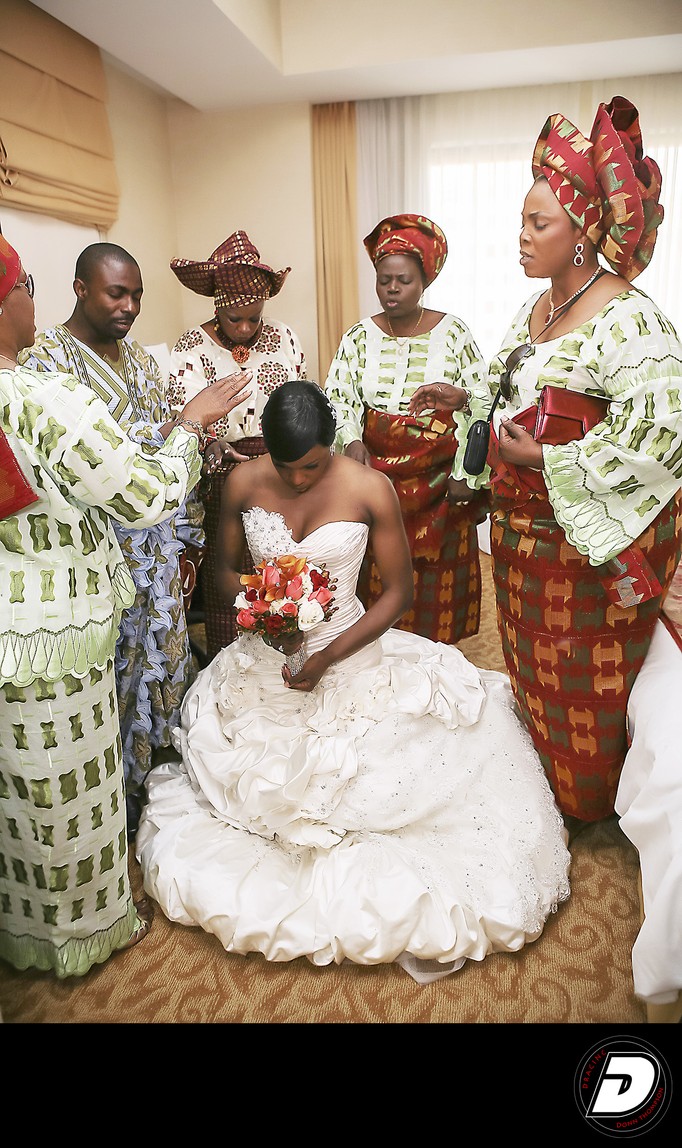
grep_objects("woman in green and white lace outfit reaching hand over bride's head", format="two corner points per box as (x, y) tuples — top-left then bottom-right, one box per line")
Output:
(0, 235), (248, 977)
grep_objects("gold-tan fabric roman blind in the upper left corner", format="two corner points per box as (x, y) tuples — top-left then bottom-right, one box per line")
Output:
(0, 0), (119, 232)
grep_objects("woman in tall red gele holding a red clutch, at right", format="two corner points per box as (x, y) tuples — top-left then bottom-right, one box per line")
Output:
(452, 96), (682, 828)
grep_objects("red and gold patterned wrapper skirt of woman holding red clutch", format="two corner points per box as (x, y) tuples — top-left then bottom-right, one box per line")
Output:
(490, 487), (682, 821)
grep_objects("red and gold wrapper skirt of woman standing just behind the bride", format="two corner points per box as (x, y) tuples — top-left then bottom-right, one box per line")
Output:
(358, 409), (488, 644)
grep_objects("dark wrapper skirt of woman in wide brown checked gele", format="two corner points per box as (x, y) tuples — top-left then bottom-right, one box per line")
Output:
(199, 437), (265, 661)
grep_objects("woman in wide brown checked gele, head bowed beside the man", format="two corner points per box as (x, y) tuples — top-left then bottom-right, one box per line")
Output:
(169, 231), (307, 660)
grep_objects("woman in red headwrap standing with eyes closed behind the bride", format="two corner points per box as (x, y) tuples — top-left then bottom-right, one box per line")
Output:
(325, 214), (487, 643)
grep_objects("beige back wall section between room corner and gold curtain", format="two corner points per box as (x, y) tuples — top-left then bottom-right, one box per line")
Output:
(163, 101), (318, 378)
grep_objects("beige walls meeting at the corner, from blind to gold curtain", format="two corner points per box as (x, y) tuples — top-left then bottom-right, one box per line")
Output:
(106, 62), (318, 378)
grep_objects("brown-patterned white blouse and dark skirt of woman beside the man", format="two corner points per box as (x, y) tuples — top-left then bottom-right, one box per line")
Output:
(168, 319), (307, 660)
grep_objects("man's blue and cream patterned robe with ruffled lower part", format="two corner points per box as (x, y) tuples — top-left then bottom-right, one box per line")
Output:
(22, 325), (196, 831)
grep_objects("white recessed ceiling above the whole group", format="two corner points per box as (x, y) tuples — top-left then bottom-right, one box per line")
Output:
(32, 0), (682, 111)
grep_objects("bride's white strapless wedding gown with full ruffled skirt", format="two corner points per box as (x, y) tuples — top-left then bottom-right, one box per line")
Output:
(137, 507), (571, 982)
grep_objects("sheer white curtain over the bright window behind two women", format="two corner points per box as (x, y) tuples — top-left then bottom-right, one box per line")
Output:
(356, 73), (682, 358)
